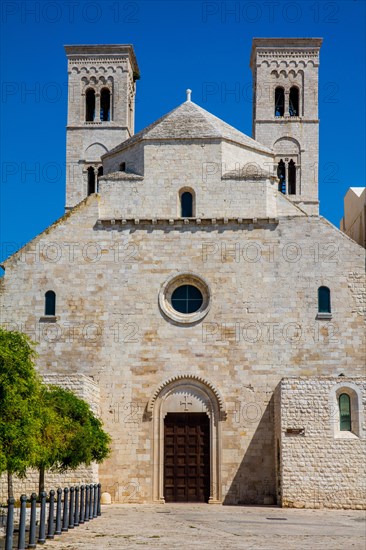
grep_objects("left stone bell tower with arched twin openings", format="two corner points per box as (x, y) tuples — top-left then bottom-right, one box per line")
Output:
(65, 44), (140, 210)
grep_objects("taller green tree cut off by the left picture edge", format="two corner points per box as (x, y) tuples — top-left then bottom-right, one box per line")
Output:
(0, 327), (41, 498)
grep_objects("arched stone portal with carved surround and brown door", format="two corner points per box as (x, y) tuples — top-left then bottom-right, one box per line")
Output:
(147, 375), (226, 504)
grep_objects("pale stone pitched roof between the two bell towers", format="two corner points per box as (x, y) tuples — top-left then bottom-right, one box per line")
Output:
(103, 100), (273, 157)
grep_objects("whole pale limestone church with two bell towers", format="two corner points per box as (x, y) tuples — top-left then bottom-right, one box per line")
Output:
(1, 38), (366, 508)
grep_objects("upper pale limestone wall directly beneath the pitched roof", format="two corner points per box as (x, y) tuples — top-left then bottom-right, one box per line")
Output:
(99, 140), (276, 218)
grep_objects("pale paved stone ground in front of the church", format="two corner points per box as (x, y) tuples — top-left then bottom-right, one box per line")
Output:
(47, 504), (366, 550)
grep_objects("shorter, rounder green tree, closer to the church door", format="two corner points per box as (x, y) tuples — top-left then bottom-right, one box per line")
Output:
(34, 386), (111, 491)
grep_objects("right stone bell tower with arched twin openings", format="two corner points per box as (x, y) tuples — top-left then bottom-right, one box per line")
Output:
(250, 38), (322, 215)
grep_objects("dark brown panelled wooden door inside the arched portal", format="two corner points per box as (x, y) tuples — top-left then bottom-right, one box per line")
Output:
(164, 413), (210, 502)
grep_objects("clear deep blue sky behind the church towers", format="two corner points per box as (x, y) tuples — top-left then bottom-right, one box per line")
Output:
(0, 0), (366, 268)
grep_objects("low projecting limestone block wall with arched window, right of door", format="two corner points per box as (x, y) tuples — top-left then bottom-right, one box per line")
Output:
(276, 376), (366, 509)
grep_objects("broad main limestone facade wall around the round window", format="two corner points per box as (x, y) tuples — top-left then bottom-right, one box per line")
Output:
(1, 197), (365, 504)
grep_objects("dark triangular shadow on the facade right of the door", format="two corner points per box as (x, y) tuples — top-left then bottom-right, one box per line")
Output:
(223, 396), (277, 505)
